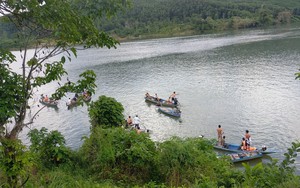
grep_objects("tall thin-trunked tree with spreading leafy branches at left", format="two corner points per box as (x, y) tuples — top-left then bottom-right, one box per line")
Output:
(0, 0), (128, 187)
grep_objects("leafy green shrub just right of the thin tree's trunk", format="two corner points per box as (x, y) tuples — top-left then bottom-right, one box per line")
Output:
(28, 127), (70, 168)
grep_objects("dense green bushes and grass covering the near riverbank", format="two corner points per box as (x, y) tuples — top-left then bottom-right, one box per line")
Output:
(0, 127), (300, 188)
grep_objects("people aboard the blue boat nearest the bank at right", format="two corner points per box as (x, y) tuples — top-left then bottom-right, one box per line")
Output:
(217, 125), (256, 151)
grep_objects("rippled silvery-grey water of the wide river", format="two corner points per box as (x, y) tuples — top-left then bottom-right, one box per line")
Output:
(15, 28), (300, 172)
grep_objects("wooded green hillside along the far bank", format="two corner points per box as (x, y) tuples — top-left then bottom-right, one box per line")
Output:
(0, 0), (300, 47)
